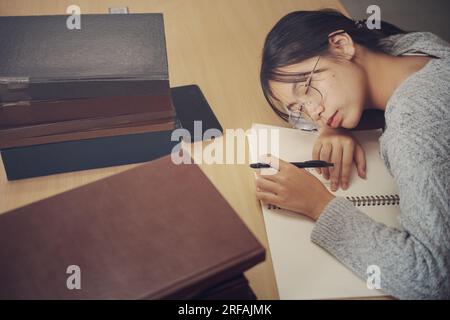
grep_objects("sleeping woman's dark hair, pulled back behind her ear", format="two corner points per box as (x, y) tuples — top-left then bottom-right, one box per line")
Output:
(260, 9), (405, 121)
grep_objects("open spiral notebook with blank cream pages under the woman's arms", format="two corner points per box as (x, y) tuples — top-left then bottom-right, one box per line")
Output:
(247, 124), (401, 299)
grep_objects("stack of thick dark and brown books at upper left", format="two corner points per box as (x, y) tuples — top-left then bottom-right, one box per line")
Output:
(0, 14), (178, 180)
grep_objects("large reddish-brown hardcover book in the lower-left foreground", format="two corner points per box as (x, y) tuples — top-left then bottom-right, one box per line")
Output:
(0, 156), (265, 299)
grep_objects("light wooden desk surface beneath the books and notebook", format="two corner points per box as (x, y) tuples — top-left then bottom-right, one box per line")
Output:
(0, 0), (343, 299)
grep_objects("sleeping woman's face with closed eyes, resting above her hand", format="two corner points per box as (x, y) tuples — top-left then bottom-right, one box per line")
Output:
(269, 57), (367, 129)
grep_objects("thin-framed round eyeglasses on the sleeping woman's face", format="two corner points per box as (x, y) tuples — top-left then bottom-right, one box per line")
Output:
(286, 57), (323, 131)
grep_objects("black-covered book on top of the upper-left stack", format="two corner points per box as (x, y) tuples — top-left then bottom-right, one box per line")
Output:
(0, 13), (169, 102)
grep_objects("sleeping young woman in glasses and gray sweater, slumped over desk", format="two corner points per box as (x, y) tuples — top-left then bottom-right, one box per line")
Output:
(256, 10), (450, 299)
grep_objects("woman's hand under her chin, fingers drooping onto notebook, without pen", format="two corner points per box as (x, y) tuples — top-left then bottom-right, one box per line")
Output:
(312, 128), (366, 191)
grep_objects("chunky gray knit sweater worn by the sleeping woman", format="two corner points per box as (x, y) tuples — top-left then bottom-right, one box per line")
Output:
(311, 32), (450, 299)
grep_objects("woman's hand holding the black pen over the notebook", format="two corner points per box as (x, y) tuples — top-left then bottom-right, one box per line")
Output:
(256, 156), (334, 220)
